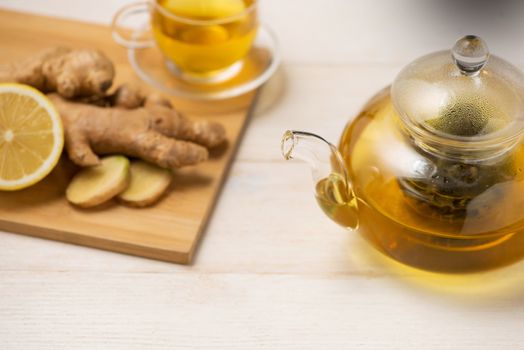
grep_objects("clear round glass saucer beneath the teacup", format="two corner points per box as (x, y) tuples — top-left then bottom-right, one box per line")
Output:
(127, 25), (280, 100)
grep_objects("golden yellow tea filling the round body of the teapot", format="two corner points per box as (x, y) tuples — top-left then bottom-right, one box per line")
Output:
(332, 89), (524, 272)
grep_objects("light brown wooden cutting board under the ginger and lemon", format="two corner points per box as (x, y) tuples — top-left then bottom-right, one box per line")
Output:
(0, 10), (256, 264)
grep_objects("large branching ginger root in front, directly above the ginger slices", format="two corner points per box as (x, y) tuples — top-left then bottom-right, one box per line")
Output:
(48, 94), (226, 169)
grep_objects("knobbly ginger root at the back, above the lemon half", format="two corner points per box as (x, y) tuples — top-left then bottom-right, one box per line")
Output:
(0, 47), (115, 98)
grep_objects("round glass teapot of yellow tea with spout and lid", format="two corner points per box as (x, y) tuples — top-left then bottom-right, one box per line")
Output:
(282, 36), (524, 273)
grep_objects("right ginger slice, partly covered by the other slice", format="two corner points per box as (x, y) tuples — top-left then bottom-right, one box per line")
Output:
(117, 160), (173, 207)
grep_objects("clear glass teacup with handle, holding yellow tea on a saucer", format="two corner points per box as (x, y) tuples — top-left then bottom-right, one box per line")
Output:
(113, 0), (258, 83)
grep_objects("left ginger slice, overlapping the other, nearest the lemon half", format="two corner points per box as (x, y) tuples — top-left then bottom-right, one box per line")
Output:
(66, 155), (130, 208)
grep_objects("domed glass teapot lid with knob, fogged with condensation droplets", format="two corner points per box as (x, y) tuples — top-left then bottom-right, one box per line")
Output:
(391, 35), (524, 143)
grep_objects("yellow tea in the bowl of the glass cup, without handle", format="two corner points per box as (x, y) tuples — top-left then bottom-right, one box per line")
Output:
(152, 0), (258, 75)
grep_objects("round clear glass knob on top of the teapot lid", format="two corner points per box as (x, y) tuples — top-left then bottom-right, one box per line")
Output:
(451, 35), (489, 75)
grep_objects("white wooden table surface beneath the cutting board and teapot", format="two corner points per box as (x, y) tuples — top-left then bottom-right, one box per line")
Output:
(0, 0), (524, 350)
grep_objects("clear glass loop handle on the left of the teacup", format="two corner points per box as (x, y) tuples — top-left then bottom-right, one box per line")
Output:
(111, 1), (155, 49)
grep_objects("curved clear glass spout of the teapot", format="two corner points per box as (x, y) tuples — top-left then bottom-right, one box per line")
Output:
(281, 130), (358, 229)
